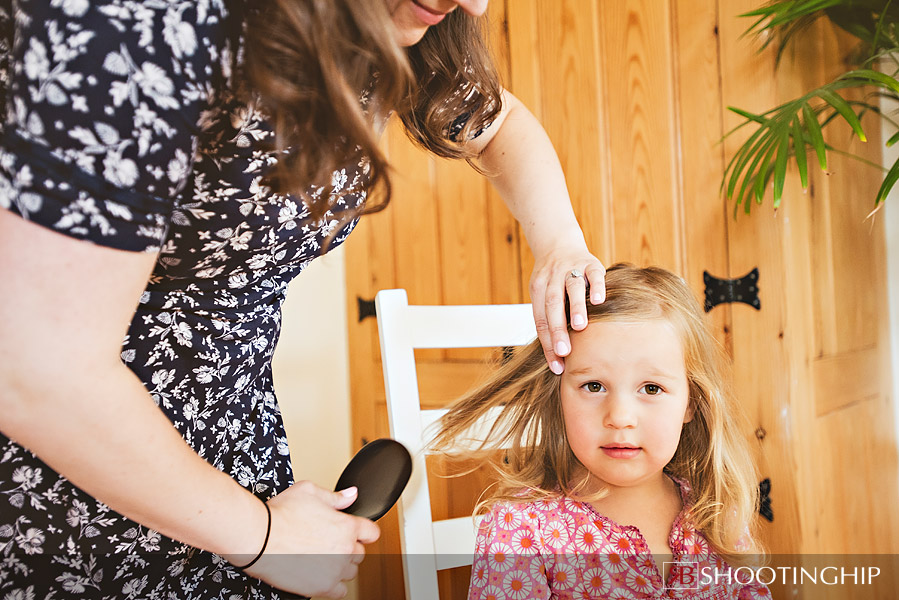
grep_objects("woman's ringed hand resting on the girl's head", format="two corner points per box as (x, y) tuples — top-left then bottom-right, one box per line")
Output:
(530, 244), (606, 375)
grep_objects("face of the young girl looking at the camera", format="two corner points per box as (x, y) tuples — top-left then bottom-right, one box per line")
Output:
(560, 318), (692, 491)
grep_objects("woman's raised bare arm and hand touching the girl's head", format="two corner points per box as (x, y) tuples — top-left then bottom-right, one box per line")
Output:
(468, 91), (605, 373)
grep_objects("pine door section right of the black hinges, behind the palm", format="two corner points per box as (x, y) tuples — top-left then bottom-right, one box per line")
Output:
(719, 0), (899, 600)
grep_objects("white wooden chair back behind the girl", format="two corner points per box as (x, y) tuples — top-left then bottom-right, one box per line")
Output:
(375, 290), (537, 600)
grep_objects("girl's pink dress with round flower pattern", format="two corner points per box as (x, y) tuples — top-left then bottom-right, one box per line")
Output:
(468, 482), (771, 600)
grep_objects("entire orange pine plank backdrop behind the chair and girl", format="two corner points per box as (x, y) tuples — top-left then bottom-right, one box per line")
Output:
(347, 0), (899, 600)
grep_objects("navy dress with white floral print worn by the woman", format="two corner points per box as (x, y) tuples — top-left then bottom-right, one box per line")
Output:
(0, 0), (366, 600)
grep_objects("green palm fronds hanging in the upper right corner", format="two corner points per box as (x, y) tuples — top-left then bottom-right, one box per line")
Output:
(721, 0), (899, 213)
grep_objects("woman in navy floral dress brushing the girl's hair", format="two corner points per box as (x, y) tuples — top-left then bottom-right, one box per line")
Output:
(0, 0), (603, 599)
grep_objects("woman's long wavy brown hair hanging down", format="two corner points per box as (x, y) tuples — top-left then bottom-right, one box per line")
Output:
(241, 0), (500, 218)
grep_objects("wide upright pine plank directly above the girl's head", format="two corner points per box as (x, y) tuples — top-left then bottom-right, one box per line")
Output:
(599, 0), (683, 272)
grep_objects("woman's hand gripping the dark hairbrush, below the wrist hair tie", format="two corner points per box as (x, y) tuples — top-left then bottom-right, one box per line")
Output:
(232, 481), (380, 598)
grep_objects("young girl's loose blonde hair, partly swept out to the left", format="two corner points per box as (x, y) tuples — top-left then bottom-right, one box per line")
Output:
(431, 264), (761, 563)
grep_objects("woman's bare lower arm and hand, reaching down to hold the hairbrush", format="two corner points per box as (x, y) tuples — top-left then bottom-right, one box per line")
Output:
(0, 209), (378, 597)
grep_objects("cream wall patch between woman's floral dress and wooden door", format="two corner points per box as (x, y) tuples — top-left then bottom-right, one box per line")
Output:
(273, 247), (357, 600)
